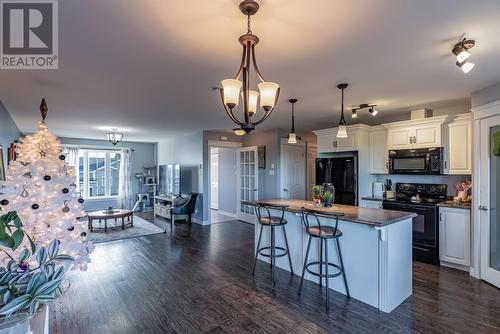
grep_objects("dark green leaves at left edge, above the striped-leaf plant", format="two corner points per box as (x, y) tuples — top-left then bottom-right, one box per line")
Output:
(0, 211), (36, 253)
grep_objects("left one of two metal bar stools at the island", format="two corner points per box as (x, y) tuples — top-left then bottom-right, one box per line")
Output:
(252, 202), (293, 286)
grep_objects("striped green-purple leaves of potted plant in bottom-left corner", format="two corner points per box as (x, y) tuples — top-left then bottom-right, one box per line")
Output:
(0, 240), (73, 316)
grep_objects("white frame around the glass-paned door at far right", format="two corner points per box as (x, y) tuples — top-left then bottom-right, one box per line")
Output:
(470, 100), (500, 279)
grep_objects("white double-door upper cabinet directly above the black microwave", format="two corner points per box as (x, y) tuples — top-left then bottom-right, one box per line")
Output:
(383, 116), (447, 150)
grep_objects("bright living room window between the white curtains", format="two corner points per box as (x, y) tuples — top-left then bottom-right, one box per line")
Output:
(78, 150), (120, 198)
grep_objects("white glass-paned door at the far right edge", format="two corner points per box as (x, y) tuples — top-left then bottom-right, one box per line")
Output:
(477, 116), (500, 288)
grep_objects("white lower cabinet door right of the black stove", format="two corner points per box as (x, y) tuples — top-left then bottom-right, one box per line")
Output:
(439, 207), (470, 266)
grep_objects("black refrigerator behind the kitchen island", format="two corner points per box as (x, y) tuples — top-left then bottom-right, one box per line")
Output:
(316, 155), (358, 205)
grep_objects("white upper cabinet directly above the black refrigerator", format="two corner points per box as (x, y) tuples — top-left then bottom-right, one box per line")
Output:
(313, 124), (369, 153)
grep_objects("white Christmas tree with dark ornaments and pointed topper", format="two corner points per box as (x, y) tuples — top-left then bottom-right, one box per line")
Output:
(0, 99), (94, 270)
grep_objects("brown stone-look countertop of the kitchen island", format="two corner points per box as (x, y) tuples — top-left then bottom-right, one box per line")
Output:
(247, 199), (417, 227)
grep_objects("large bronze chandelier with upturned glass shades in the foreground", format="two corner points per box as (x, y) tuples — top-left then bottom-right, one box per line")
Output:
(220, 0), (280, 136)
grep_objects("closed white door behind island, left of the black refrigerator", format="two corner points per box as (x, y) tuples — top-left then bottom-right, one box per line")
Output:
(280, 144), (307, 199)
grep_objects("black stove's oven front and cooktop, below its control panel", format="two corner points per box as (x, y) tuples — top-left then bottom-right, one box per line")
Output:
(383, 201), (439, 264)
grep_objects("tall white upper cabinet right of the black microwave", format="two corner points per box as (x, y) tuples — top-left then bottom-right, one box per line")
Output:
(445, 113), (472, 175)
